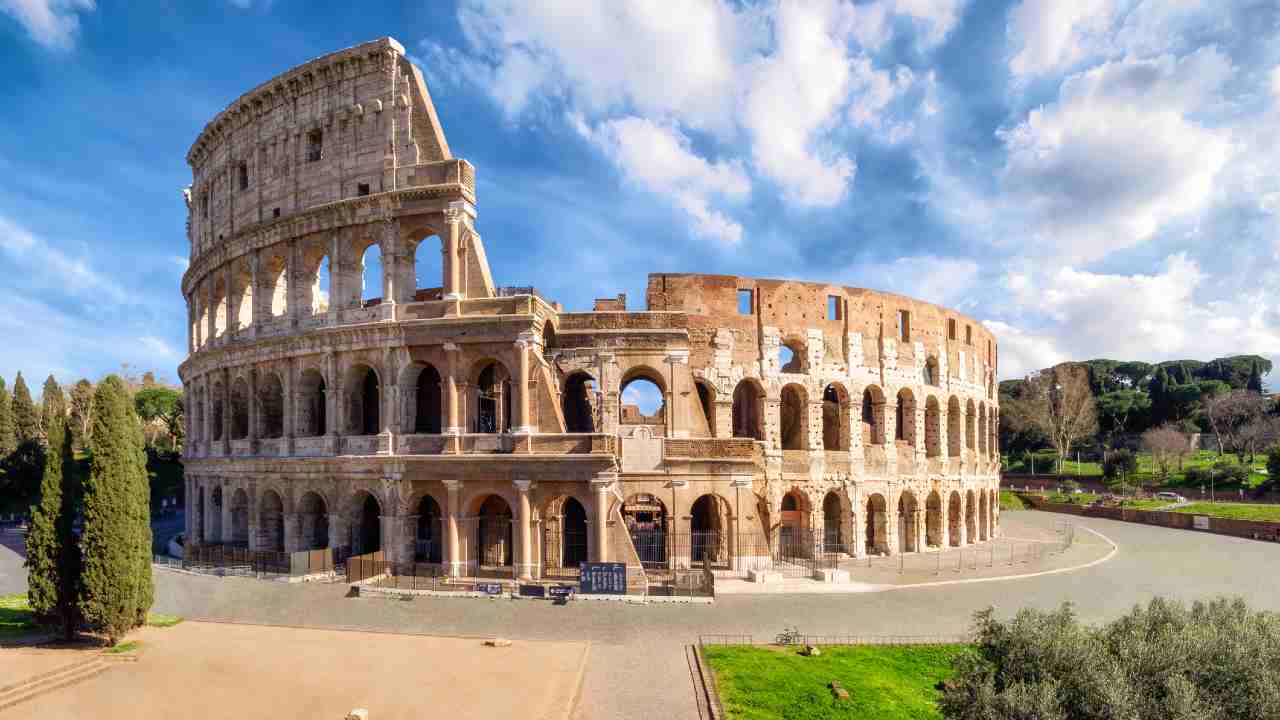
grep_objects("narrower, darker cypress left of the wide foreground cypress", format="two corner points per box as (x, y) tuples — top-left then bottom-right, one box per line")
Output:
(27, 377), (81, 639)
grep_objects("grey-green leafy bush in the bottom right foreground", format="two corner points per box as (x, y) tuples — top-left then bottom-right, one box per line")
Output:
(938, 598), (1280, 720)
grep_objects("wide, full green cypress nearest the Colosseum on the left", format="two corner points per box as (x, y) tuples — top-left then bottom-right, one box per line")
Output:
(79, 375), (154, 644)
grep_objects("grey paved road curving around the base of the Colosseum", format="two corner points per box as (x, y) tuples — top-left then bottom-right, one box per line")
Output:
(0, 512), (1280, 719)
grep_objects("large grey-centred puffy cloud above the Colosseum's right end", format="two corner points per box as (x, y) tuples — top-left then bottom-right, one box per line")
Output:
(997, 47), (1231, 261)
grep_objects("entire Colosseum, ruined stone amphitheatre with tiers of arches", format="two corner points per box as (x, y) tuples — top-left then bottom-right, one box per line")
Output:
(179, 38), (1000, 584)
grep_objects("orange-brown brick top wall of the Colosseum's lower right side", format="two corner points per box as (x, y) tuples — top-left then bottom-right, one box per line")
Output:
(646, 273), (998, 375)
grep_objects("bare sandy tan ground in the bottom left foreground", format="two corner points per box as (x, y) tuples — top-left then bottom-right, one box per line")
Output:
(0, 621), (589, 720)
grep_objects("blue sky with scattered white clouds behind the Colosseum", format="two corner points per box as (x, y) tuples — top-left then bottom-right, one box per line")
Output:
(0, 0), (1280, 382)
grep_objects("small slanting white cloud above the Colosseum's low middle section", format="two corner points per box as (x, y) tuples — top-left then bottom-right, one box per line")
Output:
(573, 117), (751, 245)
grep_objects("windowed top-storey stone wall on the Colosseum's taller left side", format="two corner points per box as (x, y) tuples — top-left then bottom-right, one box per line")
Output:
(187, 37), (458, 258)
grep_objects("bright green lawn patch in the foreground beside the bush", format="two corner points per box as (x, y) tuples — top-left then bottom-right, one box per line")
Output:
(703, 646), (965, 720)
